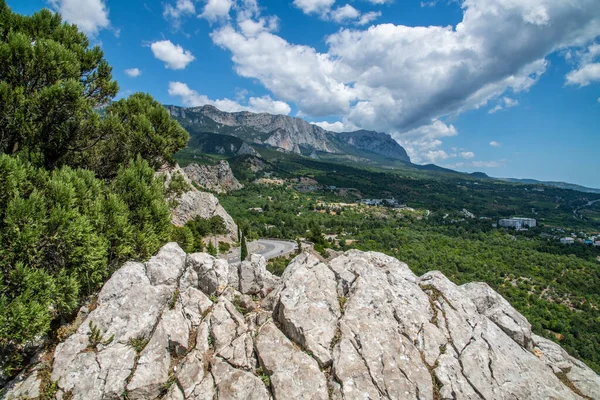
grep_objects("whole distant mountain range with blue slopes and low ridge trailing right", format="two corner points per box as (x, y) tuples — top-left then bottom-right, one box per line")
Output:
(165, 105), (600, 194)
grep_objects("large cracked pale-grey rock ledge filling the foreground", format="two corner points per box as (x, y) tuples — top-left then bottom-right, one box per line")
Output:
(4, 244), (600, 400)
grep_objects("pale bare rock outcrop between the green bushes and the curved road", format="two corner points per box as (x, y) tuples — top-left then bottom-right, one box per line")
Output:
(157, 165), (239, 240)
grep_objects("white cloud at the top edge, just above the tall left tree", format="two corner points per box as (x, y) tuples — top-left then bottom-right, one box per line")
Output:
(49, 0), (110, 37)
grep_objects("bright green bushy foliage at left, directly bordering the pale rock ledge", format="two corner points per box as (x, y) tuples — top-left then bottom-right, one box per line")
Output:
(0, 155), (171, 376)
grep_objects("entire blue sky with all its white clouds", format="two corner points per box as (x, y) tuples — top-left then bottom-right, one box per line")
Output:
(7, 0), (600, 188)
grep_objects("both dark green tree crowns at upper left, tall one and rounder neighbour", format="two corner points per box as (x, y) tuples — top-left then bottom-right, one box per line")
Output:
(0, 4), (188, 177)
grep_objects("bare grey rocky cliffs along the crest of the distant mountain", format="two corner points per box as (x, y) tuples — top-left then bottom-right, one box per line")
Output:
(166, 105), (410, 163)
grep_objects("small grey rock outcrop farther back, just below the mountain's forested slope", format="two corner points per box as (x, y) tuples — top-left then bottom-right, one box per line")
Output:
(183, 160), (244, 193)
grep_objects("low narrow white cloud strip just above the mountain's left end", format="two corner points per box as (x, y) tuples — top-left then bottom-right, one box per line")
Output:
(169, 82), (292, 115)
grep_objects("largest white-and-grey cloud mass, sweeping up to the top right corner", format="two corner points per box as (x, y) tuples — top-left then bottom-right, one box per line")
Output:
(205, 0), (600, 159)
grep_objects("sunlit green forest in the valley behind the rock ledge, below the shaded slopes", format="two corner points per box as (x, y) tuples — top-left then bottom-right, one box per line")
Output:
(220, 183), (600, 372)
